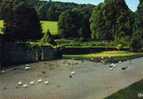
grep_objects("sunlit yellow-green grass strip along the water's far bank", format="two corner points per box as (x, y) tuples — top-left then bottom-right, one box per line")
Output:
(64, 51), (143, 59)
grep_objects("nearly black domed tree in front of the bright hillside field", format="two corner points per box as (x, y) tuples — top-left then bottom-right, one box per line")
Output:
(5, 5), (42, 41)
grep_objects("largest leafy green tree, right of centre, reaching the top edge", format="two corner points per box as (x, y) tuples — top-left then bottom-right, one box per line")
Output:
(91, 0), (134, 40)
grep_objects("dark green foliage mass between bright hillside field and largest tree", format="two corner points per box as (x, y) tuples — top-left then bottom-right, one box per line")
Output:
(58, 5), (93, 40)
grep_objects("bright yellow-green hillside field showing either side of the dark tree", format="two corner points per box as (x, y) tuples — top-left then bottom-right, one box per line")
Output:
(0, 20), (58, 35)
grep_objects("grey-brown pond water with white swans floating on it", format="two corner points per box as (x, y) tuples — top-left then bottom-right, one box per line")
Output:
(0, 58), (143, 99)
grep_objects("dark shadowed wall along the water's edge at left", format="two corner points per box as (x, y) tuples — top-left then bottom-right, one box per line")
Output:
(0, 42), (62, 65)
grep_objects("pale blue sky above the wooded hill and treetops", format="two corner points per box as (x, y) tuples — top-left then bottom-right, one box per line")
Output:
(53, 0), (139, 11)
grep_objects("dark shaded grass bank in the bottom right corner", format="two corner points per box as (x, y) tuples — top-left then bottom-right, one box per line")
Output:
(104, 80), (143, 99)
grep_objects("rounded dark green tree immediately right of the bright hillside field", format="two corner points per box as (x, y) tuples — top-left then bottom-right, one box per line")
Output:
(58, 10), (81, 38)
